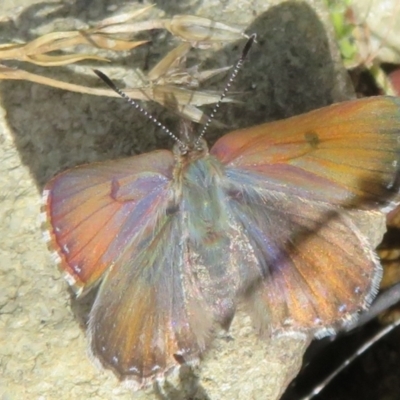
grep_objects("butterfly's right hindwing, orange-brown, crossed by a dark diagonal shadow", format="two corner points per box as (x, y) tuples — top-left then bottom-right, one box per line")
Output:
(222, 174), (381, 336)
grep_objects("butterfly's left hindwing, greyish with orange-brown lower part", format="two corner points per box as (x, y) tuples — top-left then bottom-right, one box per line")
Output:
(89, 208), (213, 384)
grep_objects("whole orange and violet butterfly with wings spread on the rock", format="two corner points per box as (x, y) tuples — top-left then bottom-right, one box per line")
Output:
(43, 36), (400, 385)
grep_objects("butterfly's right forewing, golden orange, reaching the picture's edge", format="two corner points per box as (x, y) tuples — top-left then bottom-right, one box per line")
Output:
(211, 96), (400, 208)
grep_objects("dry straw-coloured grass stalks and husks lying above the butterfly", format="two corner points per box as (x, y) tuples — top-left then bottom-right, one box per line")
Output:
(0, 6), (245, 122)
